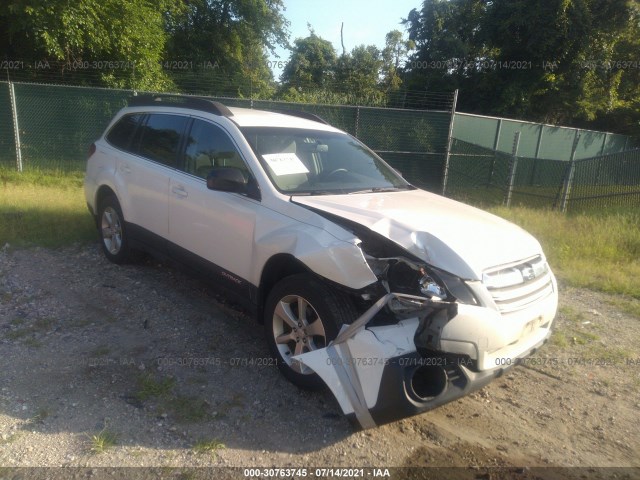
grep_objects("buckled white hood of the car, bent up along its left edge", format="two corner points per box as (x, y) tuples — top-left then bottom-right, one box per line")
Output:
(292, 190), (542, 280)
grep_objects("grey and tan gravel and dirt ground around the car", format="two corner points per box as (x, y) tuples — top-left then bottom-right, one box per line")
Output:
(0, 244), (640, 479)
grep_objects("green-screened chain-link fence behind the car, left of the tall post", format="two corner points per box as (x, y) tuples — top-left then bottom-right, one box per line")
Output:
(0, 82), (453, 189)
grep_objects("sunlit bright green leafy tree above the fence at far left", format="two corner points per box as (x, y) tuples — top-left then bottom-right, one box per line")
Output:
(0, 0), (180, 89)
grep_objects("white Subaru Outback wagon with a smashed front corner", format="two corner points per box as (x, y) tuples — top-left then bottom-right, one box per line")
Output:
(85, 95), (558, 428)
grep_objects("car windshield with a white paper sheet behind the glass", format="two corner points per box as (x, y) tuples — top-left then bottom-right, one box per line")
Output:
(242, 127), (413, 195)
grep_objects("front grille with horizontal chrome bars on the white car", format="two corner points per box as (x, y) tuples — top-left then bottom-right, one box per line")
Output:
(482, 255), (553, 313)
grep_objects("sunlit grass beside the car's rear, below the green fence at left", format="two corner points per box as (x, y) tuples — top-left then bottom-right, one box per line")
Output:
(0, 169), (96, 248)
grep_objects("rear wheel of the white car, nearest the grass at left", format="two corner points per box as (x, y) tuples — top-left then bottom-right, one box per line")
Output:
(98, 195), (131, 264)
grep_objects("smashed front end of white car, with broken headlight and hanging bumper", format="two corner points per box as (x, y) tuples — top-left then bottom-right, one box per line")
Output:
(294, 216), (557, 429)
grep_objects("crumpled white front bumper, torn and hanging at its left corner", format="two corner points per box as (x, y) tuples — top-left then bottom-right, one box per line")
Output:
(294, 294), (557, 429)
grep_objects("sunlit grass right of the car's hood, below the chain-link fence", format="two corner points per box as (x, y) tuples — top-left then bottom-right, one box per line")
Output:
(491, 207), (640, 300)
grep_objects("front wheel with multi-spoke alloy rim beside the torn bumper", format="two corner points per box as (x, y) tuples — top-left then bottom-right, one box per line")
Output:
(264, 273), (357, 390)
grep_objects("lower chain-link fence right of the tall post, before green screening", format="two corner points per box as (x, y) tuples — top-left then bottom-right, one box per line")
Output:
(446, 135), (640, 211)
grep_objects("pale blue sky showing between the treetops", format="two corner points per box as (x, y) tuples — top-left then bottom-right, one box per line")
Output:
(269, 0), (422, 80)
